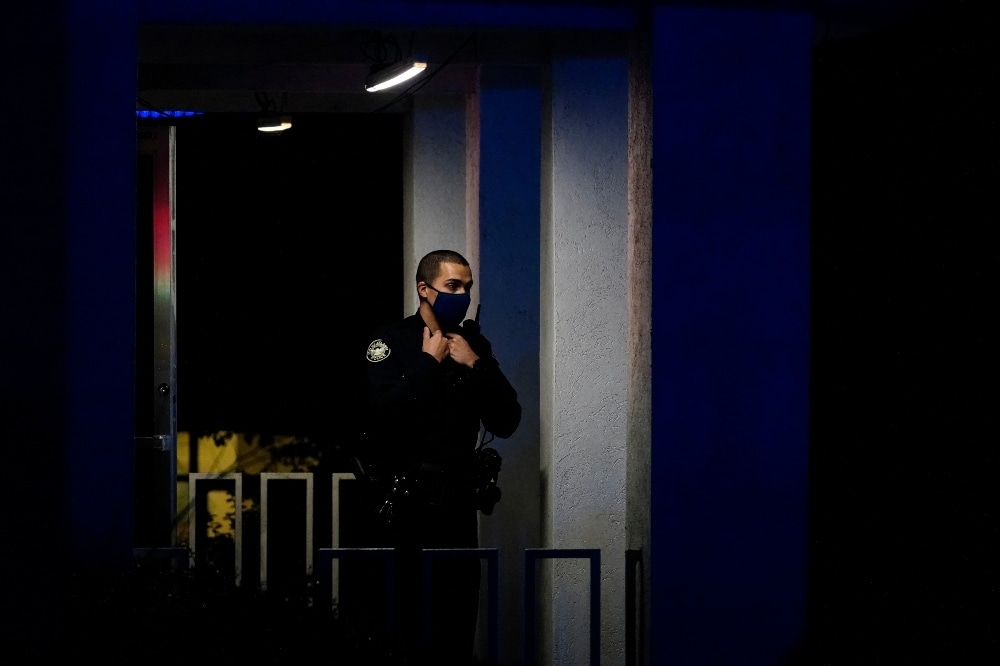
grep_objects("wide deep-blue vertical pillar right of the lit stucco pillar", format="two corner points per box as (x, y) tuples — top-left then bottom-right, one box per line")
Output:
(650, 8), (812, 666)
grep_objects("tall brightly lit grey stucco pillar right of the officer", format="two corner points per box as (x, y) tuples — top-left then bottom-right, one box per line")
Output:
(539, 46), (628, 664)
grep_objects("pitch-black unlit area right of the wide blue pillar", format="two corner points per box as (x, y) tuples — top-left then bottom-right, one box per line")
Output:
(806, 3), (1000, 665)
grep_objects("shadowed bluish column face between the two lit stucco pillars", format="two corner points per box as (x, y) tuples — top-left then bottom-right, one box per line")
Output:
(477, 67), (541, 664)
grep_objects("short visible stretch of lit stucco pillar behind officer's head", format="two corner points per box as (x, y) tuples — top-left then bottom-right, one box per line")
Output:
(401, 94), (468, 316)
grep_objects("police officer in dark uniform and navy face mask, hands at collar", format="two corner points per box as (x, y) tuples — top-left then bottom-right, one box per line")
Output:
(361, 250), (521, 664)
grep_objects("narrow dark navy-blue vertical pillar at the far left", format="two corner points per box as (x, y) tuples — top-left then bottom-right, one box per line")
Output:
(66, 0), (138, 564)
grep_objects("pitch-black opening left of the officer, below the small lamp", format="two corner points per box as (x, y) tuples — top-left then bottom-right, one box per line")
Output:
(176, 113), (402, 438)
